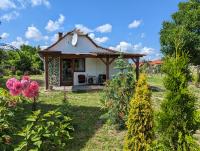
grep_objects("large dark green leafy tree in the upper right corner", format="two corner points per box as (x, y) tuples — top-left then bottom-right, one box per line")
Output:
(160, 0), (200, 64)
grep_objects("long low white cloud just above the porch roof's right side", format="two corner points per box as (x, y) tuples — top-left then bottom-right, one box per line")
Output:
(110, 41), (155, 55)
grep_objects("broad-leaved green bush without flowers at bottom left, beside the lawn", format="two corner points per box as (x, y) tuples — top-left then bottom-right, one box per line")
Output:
(15, 110), (73, 151)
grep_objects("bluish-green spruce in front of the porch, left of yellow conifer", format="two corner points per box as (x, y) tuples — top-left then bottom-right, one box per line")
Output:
(101, 57), (135, 128)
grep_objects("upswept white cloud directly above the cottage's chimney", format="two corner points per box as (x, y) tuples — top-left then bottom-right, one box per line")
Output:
(45, 14), (65, 32)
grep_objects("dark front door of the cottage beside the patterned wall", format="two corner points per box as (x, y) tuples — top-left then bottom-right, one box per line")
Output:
(61, 59), (74, 85)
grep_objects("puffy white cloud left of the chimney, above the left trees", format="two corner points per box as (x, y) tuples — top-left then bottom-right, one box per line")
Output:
(25, 25), (49, 41)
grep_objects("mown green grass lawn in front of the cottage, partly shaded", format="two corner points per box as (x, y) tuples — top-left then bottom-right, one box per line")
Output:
(0, 75), (200, 151)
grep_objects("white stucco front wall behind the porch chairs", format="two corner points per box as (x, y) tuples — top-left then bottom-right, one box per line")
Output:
(74, 58), (117, 85)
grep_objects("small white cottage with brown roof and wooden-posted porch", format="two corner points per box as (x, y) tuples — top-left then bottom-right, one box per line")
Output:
(39, 29), (144, 89)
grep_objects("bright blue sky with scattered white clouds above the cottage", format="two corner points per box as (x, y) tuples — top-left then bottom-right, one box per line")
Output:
(0, 0), (186, 59)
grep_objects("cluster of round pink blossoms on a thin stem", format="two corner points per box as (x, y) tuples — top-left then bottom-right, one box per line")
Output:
(6, 76), (39, 110)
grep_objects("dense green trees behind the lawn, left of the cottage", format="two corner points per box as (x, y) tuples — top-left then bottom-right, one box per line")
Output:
(0, 45), (43, 75)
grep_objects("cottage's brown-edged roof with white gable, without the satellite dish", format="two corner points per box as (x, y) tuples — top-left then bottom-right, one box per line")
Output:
(40, 29), (144, 57)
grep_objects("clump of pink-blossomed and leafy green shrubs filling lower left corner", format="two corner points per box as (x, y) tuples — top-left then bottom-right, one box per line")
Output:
(0, 76), (73, 151)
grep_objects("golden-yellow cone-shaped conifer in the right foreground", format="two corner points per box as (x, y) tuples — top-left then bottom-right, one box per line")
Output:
(124, 74), (154, 151)
